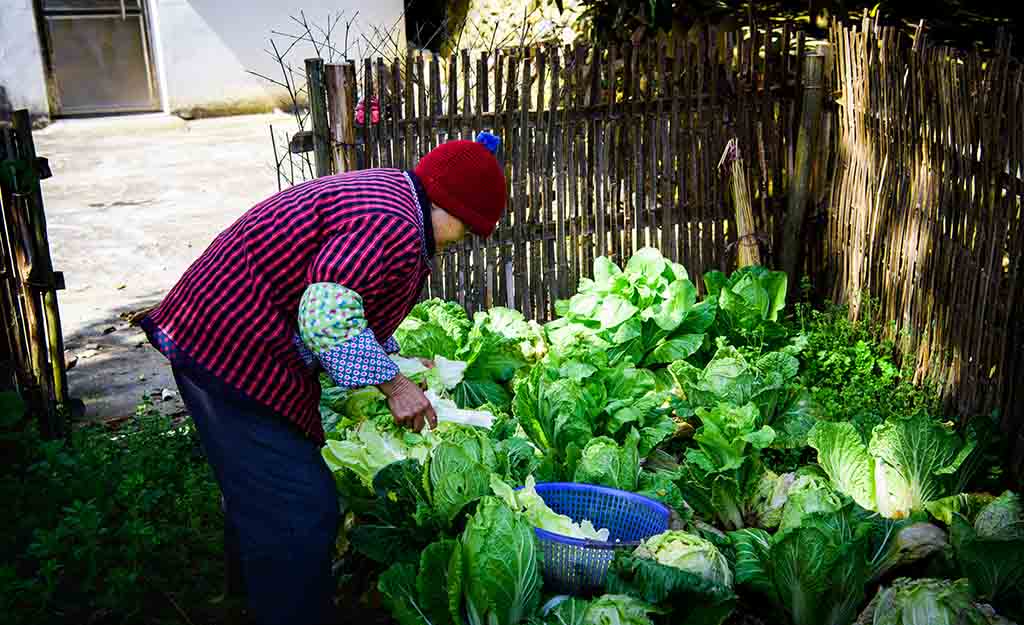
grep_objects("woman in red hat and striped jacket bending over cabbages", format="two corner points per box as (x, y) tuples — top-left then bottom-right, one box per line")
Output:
(142, 133), (506, 625)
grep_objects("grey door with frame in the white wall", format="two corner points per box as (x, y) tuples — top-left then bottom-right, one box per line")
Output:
(41, 0), (160, 115)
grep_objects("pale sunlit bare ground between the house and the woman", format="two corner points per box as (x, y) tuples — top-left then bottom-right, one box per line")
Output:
(36, 114), (294, 420)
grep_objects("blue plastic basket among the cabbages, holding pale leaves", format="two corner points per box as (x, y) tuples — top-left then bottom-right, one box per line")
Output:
(520, 482), (670, 594)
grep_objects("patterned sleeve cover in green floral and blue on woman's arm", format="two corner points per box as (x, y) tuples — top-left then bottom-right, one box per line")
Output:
(299, 282), (398, 388)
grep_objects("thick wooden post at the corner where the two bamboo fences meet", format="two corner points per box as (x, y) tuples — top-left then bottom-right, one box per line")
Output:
(778, 44), (825, 284)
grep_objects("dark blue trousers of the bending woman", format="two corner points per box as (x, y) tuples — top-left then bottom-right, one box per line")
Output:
(174, 369), (339, 625)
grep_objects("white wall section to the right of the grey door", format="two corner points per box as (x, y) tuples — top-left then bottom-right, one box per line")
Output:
(152, 0), (404, 113)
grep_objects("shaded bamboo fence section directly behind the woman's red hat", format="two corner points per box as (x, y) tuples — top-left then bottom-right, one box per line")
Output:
(326, 25), (804, 320)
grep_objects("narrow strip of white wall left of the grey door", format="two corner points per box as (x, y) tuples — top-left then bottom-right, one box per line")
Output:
(0, 0), (50, 116)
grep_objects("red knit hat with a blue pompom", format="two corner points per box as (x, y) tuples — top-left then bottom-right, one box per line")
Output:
(414, 132), (507, 237)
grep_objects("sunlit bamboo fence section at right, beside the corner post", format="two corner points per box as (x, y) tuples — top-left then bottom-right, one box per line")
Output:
(814, 18), (1024, 462)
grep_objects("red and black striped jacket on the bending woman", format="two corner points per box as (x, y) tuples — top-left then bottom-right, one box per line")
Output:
(142, 169), (434, 443)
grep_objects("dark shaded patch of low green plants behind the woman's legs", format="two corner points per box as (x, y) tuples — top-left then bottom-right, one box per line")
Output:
(0, 397), (227, 624)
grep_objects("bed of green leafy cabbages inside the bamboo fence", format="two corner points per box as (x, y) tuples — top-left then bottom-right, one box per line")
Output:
(322, 248), (1024, 625)
